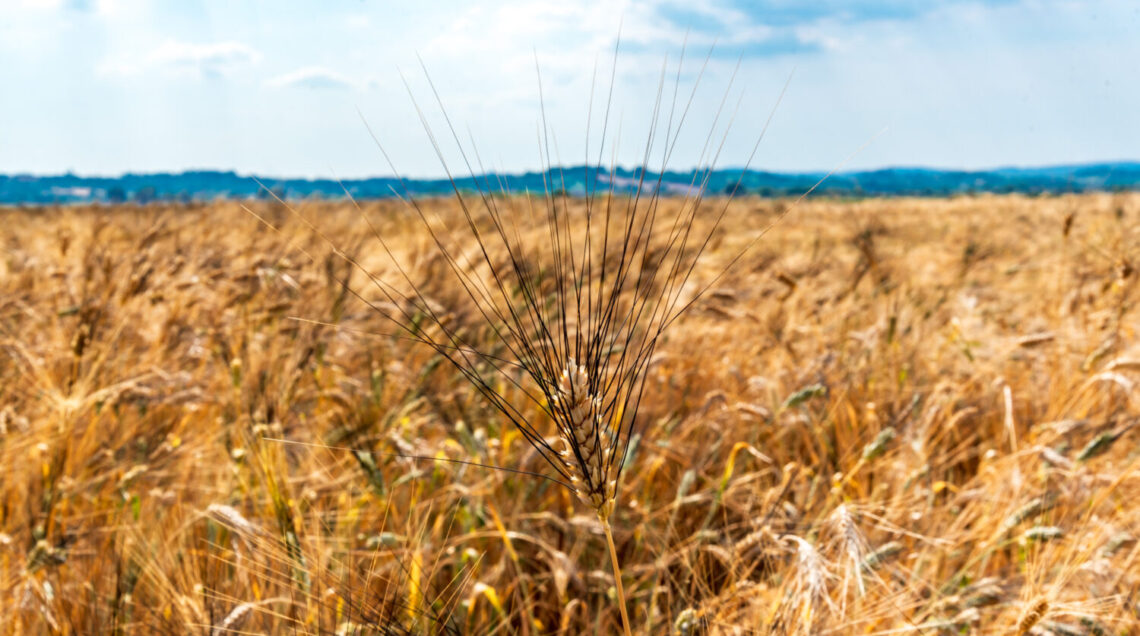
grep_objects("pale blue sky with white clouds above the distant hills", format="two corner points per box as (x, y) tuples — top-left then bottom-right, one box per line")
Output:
(0, 0), (1140, 178)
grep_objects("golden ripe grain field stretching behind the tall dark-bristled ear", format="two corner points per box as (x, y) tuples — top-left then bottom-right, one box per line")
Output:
(0, 194), (1140, 635)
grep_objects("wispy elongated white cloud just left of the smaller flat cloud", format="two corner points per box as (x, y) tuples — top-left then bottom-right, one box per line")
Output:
(99, 40), (261, 76)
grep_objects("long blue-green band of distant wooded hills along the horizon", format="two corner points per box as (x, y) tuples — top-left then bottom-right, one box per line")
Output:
(0, 162), (1140, 205)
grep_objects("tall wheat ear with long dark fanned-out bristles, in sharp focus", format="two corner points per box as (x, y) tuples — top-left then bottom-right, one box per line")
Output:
(243, 32), (802, 635)
